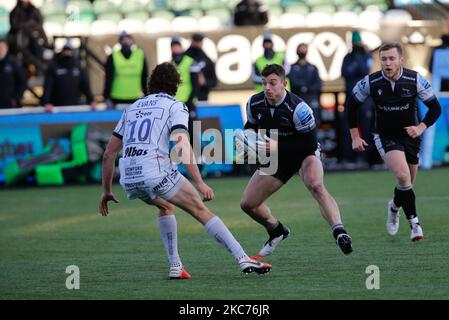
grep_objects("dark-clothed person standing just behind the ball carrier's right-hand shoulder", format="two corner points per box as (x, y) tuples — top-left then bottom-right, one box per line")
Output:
(289, 43), (322, 128)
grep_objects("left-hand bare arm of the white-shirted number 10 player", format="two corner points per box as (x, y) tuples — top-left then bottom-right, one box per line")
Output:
(99, 136), (122, 216)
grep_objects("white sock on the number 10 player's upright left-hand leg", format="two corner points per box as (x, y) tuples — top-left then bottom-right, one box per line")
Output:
(158, 214), (182, 268)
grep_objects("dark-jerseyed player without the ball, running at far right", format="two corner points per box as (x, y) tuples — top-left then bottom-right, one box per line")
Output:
(347, 43), (441, 241)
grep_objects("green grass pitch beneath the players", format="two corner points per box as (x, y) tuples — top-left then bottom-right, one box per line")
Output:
(0, 168), (449, 300)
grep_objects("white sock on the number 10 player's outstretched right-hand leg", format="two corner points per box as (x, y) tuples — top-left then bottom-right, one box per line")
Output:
(204, 216), (248, 261)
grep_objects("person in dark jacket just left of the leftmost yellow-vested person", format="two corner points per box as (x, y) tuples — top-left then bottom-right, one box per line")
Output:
(41, 43), (96, 112)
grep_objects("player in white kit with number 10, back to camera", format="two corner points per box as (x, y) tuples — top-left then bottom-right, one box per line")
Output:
(99, 63), (271, 279)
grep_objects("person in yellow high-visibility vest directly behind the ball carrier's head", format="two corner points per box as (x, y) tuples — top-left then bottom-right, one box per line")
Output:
(252, 32), (290, 92)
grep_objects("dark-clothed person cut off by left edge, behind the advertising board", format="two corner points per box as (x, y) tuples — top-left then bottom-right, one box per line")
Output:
(0, 39), (26, 108)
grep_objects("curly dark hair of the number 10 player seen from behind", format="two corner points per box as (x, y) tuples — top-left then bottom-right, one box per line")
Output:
(147, 62), (181, 96)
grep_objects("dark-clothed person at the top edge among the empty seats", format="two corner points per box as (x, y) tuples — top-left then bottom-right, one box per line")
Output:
(234, 0), (268, 26)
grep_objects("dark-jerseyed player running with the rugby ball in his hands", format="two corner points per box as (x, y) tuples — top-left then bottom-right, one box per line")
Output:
(240, 64), (352, 259)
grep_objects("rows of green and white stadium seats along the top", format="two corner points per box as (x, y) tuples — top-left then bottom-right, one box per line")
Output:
(0, 0), (400, 36)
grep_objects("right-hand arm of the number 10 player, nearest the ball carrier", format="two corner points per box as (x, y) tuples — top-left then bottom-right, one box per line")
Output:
(172, 132), (215, 201)
